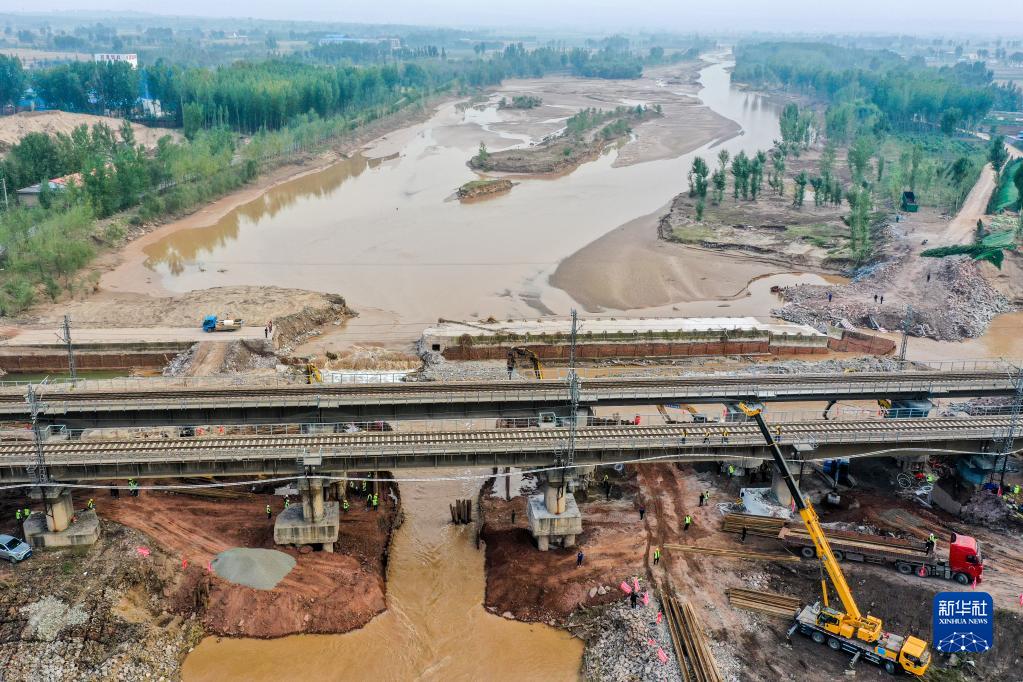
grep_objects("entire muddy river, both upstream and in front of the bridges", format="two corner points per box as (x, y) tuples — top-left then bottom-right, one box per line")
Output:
(178, 58), (806, 681)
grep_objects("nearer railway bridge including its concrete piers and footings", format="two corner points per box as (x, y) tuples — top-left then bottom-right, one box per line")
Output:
(6, 416), (1013, 549)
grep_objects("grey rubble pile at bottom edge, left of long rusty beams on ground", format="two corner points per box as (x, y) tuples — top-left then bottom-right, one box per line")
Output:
(582, 599), (682, 682)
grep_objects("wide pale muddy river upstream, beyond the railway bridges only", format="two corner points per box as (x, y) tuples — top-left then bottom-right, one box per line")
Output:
(131, 55), (812, 325)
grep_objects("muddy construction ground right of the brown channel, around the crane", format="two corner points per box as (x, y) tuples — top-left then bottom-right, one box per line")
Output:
(483, 460), (1023, 682)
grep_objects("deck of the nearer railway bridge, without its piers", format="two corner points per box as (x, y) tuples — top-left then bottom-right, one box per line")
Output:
(0, 416), (1010, 481)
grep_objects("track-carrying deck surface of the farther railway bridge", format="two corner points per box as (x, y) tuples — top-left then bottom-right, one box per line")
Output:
(0, 370), (1014, 420)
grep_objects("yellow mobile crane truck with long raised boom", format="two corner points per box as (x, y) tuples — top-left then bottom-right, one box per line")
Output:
(740, 403), (931, 676)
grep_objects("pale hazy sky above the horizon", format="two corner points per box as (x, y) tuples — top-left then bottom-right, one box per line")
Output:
(2, 0), (1023, 35)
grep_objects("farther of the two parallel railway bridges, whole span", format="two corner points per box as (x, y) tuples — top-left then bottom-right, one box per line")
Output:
(0, 363), (1016, 428)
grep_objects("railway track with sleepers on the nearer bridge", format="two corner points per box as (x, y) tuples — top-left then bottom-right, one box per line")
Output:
(0, 416), (1010, 463)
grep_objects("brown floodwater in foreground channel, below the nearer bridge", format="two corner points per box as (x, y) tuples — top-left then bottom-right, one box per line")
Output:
(182, 469), (583, 682)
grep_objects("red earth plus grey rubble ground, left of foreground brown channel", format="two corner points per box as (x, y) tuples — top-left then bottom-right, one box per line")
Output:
(0, 481), (401, 682)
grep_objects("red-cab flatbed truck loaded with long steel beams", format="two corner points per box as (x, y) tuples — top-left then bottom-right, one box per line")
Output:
(777, 527), (984, 585)
